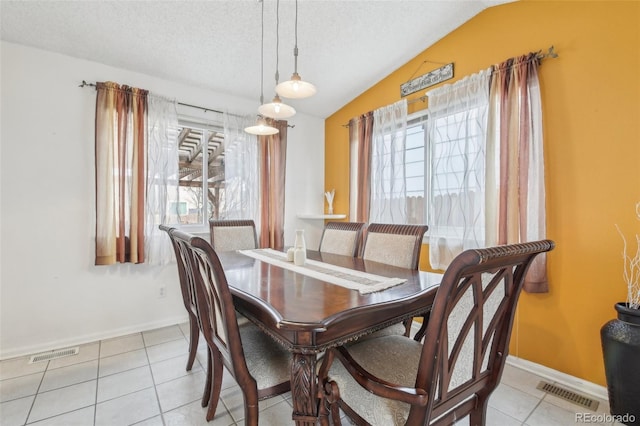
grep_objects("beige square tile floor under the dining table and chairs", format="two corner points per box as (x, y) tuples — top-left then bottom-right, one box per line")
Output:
(0, 324), (612, 426)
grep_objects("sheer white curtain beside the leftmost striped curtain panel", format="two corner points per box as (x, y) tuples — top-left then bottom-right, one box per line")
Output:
(145, 94), (179, 265)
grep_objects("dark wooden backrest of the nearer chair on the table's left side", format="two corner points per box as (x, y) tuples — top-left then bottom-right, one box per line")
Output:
(172, 230), (255, 383)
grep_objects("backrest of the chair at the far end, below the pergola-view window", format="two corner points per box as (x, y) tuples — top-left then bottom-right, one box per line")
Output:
(209, 219), (258, 252)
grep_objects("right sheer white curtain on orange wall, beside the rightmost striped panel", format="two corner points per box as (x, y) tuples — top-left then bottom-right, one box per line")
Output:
(427, 69), (495, 269)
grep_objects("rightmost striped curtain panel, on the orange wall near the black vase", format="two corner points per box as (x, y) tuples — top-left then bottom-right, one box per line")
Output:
(487, 53), (548, 293)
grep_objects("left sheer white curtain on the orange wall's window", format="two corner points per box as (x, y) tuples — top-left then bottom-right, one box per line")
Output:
(369, 99), (407, 224)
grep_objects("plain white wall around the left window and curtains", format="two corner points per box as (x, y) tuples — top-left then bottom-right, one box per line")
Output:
(0, 42), (324, 358)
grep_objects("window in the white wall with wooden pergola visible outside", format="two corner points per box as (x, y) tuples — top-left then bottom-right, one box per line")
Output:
(169, 119), (224, 229)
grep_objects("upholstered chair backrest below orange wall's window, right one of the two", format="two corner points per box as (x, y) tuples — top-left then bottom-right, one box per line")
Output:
(362, 223), (429, 269)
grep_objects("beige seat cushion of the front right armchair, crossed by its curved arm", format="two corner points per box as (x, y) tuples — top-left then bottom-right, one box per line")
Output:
(329, 336), (422, 426)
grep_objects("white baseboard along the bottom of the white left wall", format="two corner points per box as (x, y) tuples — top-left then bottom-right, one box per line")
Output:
(0, 315), (189, 360)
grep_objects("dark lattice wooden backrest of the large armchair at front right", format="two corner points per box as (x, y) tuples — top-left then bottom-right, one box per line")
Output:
(407, 240), (555, 424)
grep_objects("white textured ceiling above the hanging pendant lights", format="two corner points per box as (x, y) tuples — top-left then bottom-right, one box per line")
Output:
(0, 0), (512, 118)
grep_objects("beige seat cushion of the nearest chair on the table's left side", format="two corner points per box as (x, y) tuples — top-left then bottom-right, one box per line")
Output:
(240, 322), (291, 389)
